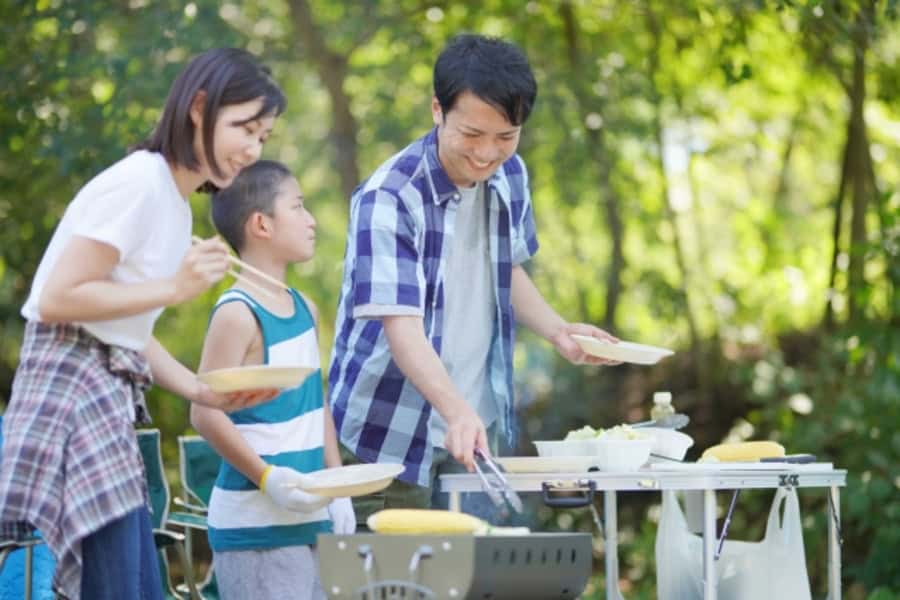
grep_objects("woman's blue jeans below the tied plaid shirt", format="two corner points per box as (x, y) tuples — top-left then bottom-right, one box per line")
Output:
(81, 506), (163, 600)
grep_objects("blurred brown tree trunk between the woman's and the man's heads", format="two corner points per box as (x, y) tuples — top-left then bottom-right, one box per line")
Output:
(288, 0), (360, 202)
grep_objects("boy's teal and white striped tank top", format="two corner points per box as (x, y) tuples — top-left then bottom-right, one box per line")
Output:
(207, 289), (331, 551)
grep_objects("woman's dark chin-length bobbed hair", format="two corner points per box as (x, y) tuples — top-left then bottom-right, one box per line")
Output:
(134, 48), (287, 189)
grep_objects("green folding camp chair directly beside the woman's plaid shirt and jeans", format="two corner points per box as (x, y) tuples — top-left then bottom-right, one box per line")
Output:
(137, 429), (202, 600)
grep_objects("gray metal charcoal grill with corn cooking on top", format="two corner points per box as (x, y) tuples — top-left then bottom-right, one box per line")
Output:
(318, 533), (592, 600)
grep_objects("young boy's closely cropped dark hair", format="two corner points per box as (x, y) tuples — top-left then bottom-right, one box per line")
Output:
(212, 160), (293, 254)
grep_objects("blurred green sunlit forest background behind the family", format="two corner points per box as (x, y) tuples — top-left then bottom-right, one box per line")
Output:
(0, 0), (900, 599)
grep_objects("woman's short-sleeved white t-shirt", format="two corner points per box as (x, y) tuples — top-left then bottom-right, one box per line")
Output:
(22, 150), (191, 351)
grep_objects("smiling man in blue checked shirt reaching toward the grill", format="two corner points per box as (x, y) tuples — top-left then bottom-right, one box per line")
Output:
(329, 35), (616, 522)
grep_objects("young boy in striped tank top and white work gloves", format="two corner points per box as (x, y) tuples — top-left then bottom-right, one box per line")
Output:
(191, 160), (356, 600)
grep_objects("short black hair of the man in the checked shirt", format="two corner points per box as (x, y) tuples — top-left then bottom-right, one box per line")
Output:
(434, 34), (537, 125)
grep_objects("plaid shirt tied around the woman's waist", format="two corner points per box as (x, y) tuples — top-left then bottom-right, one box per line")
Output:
(0, 322), (152, 600)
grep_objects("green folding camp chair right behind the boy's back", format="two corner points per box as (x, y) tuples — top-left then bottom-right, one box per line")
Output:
(168, 435), (222, 600)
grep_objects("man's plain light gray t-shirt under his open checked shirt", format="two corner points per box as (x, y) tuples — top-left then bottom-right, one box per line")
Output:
(430, 183), (497, 445)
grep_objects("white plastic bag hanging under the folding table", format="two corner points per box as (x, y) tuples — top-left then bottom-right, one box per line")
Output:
(656, 488), (811, 600)
